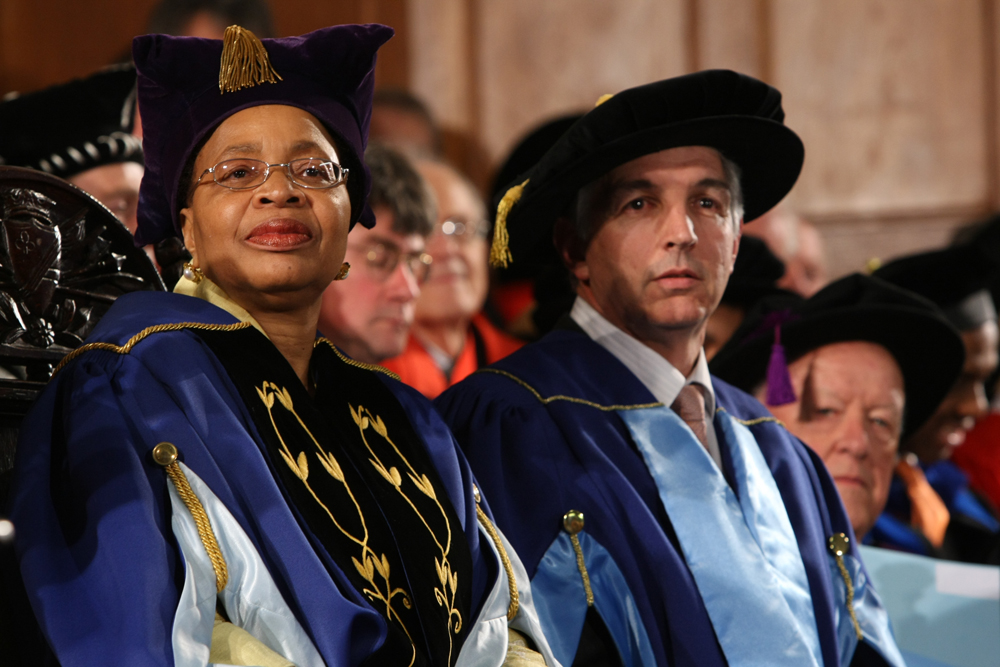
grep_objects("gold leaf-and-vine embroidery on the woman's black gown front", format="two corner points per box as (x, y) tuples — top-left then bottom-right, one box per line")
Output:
(257, 382), (462, 665)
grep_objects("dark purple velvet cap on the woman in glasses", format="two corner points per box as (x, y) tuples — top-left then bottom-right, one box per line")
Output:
(132, 24), (393, 245)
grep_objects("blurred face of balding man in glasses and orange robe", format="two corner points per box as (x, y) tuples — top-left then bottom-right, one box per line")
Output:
(417, 162), (489, 323)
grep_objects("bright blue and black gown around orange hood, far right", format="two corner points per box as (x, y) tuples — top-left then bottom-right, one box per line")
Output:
(865, 461), (1000, 565)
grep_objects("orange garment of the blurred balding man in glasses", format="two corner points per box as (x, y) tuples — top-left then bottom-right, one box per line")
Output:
(382, 314), (524, 398)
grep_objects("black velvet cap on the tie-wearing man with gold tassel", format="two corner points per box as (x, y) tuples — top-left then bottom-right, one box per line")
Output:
(495, 70), (805, 262)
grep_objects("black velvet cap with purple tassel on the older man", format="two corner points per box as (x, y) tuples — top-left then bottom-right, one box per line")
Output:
(709, 273), (965, 437)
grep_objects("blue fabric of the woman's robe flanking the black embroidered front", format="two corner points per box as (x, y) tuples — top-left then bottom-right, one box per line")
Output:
(10, 292), (548, 667)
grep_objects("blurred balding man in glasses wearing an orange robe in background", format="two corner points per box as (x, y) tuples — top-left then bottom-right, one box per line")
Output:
(384, 161), (521, 398)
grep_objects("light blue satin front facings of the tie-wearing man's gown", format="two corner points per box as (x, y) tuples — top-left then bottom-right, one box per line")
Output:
(618, 407), (823, 667)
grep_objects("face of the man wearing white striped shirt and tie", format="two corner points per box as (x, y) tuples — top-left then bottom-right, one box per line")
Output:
(564, 146), (739, 346)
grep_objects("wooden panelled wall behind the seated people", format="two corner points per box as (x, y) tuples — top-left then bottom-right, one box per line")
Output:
(0, 0), (1000, 275)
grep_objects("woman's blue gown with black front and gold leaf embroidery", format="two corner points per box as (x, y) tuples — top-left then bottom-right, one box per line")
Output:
(10, 284), (553, 667)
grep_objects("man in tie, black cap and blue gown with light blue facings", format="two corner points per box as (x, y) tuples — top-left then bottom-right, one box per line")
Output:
(437, 71), (901, 667)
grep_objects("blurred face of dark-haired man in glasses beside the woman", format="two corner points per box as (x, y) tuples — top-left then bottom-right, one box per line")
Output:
(319, 207), (424, 364)
